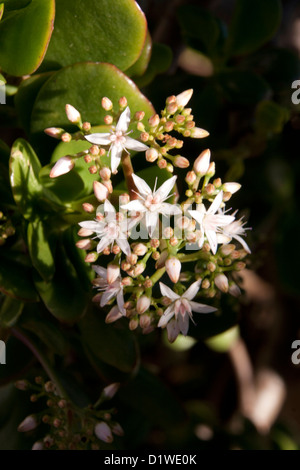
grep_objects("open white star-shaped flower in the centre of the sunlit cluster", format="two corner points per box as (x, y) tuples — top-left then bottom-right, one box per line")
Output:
(121, 174), (181, 237)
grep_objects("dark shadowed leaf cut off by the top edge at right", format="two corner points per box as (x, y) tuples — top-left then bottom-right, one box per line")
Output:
(226, 0), (281, 57)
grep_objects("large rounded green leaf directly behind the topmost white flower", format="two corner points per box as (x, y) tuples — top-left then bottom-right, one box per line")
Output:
(31, 63), (154, 163)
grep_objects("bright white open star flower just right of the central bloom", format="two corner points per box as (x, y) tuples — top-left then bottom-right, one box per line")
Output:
(189, 191), (234, 254)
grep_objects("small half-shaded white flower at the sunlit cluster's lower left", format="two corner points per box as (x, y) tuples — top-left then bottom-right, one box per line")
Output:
(93, 266), (126, 315)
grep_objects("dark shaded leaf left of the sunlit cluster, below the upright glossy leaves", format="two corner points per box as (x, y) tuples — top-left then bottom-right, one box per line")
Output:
(34, 244), (89, 322)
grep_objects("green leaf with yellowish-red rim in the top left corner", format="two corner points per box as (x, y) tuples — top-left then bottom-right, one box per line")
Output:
(0, 0), (55, 76)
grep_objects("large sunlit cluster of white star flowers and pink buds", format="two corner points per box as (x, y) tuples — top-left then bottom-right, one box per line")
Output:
(46, 90), (250, 341)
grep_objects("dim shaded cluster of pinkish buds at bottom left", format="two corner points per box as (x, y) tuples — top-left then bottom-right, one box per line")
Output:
(15, 377), (123, 450)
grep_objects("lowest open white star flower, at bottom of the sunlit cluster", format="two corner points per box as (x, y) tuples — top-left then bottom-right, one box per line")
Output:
(157, 280), (217, 341)
